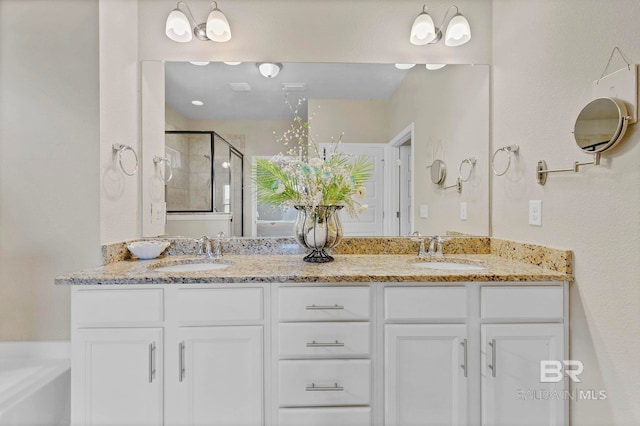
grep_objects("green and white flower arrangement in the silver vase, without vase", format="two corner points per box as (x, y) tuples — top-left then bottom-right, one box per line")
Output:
(254, 98), (373, 217)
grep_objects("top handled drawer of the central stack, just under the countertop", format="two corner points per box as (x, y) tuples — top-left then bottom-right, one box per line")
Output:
(279, 287), (371, 321)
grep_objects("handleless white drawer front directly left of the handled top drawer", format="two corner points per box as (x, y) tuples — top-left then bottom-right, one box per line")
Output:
(177, 288), (264, 322)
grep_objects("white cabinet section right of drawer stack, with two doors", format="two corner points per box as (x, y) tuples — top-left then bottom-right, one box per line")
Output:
(383, 283), (568, 426)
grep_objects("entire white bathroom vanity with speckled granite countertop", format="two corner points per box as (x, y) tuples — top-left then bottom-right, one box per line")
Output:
(57, 241), (571, 426)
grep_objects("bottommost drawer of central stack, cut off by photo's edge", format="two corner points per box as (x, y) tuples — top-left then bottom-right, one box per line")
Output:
(278, 407), (371, 426)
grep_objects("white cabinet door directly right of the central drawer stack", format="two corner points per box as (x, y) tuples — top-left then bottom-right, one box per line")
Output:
(385, 324), (468, 426)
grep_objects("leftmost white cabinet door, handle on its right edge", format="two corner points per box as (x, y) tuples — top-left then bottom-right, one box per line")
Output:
(72, 328), (163, 426)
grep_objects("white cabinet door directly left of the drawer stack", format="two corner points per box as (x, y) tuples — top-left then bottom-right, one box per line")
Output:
(166, 326), (264, 426)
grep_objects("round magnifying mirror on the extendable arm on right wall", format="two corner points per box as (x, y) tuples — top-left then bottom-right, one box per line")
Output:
(573, 98), (629, 154)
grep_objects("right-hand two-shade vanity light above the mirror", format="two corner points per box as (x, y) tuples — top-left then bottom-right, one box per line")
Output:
(409, 4), (471, 47)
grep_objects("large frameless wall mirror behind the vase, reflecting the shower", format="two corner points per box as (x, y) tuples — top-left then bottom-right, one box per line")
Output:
(164, 62), (490, 236)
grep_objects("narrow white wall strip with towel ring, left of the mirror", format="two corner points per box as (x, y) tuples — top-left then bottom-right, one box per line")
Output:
(99, 0), (142, 244)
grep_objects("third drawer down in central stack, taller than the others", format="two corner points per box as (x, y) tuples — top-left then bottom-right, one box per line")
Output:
(279, 360), (371, 407)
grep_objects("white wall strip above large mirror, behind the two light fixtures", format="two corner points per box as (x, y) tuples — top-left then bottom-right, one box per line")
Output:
(139, 0), (491, 64)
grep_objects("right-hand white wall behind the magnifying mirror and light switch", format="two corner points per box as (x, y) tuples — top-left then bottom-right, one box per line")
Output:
(492, 0), (640, 426)
